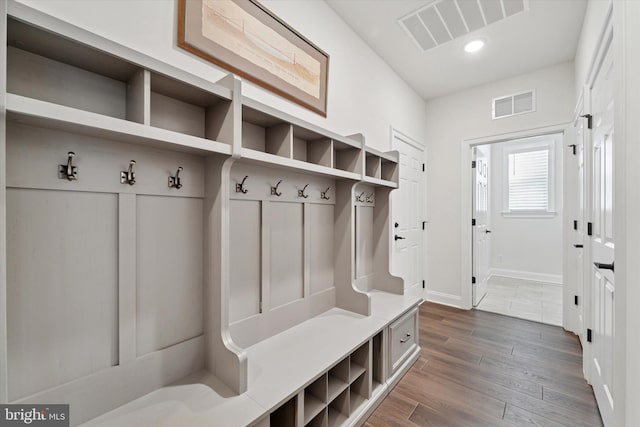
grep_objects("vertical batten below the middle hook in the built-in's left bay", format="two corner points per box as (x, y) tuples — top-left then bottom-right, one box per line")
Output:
(118, 193), (137, 365)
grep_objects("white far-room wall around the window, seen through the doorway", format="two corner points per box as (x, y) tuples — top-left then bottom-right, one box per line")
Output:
(490, 142), (563, 283)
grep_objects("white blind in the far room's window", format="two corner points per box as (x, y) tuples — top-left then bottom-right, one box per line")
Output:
(508, 148), (549, 211)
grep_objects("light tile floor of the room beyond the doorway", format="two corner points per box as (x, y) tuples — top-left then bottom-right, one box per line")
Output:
(477, 276), (562, 326)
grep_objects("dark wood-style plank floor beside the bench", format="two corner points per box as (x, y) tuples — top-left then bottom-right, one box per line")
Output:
(365, 303), (602, 427)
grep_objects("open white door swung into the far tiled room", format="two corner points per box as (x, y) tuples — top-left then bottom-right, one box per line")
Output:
(471, 146), (491, 307)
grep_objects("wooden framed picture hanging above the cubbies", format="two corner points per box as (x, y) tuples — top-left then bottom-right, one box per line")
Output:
(178, 0), (329, 117)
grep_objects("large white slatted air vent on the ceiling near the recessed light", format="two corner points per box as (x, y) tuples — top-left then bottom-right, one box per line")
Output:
(398, 0), (529, 51)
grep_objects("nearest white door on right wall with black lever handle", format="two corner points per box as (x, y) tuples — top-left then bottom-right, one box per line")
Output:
(588, 49), (615, 426)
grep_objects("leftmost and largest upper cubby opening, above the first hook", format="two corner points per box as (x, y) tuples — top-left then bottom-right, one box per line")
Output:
(7, 18), (144, 123)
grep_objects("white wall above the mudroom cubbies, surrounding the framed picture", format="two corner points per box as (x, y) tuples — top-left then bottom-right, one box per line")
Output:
(12, 0), (426, 150)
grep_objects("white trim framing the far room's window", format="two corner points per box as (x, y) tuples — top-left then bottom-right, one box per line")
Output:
(502, 134), (562, 218)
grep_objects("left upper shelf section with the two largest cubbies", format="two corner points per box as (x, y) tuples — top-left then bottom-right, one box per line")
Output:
(7, 17), (233, 158)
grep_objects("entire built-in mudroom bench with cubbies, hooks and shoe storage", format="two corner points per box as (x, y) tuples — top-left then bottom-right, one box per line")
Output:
(0, 1), (422, 427)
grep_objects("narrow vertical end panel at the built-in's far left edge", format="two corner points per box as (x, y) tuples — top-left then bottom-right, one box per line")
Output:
(0, 1), (9, 403)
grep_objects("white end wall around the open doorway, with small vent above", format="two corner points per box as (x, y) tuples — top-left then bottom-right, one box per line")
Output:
(427, 62), (575, 304)
